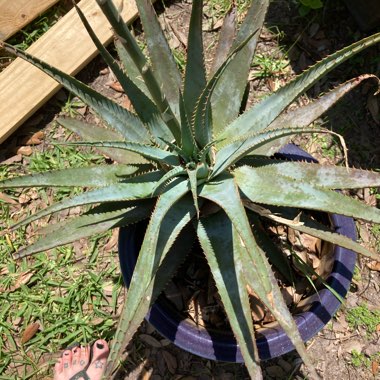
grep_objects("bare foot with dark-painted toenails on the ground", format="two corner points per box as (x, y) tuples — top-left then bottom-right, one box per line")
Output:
(54, 339), (109, 380)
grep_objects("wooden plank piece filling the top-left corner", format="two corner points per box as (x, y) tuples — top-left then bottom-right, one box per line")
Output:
(0, 0), (59, 41)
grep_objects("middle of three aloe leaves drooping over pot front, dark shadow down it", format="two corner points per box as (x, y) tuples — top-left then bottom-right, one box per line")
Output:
(197, 211), (262, 379)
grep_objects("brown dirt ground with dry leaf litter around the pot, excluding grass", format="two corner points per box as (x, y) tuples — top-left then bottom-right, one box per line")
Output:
(2, 0), (380, 380)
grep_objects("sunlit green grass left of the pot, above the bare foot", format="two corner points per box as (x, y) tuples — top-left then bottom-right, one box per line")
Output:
(0, 124), (122, 380)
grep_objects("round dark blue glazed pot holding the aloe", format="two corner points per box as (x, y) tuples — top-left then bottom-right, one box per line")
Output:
(119, 144), (356, 363)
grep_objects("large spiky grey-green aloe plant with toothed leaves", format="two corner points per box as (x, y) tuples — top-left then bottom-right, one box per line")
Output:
(0, 0), (380, 379)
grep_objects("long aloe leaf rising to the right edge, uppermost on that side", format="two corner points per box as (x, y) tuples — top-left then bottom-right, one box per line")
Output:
(218, 33), (380, 143)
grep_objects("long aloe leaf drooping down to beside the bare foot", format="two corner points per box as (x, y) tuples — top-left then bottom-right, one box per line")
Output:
(104, 186), (195, 378)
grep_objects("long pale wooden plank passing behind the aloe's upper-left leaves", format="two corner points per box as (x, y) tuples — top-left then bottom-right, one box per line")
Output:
(0, 0), (141, 143)
